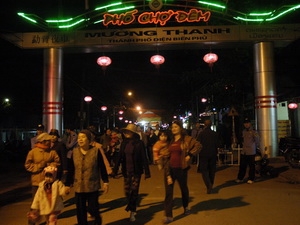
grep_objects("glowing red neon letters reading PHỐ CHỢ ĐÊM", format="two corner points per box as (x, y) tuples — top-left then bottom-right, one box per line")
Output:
(103, 9), (211, 26)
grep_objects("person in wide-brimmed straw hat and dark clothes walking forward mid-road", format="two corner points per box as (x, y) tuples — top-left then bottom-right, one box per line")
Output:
(113, 124), (151, 222)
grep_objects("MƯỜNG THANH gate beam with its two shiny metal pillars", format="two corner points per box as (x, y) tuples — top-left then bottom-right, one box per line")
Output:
(1, 24), (300, 157)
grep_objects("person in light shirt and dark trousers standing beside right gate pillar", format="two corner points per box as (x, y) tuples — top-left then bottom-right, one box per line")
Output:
(235, 118), (259, 184)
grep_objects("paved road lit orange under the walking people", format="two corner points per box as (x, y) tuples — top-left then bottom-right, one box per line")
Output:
(0, 158), (300, 225)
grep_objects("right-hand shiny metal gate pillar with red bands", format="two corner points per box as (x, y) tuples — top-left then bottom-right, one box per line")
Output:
(254, 42), (278, 157)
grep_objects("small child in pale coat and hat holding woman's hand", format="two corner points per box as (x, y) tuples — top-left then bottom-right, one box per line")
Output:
(27, 166), (70, 225)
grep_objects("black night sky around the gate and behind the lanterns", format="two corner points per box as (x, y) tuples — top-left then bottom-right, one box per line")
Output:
(0, 0), (300, 128)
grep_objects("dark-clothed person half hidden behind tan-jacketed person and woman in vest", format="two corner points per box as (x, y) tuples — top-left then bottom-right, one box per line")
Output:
(49, 129), (68, 183)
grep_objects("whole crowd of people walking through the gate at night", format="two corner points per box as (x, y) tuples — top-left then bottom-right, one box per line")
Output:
(25, 120), (259, 225)
